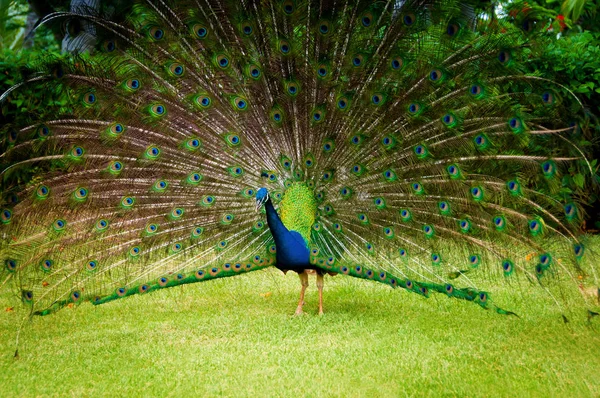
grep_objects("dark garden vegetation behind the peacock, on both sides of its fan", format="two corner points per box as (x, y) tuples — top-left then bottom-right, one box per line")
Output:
(0, 0), (600, 224)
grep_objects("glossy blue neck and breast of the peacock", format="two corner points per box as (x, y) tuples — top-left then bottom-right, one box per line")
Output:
(265, 199), (310, 270)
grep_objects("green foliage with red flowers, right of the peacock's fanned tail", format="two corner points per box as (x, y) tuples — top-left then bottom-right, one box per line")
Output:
(501, 0), (600, 211)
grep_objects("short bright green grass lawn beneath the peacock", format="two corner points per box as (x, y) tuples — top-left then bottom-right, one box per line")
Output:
(0, 269), (600, 397)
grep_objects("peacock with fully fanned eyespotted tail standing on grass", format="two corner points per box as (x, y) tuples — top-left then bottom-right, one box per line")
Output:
(0, 0), (598, 324)
